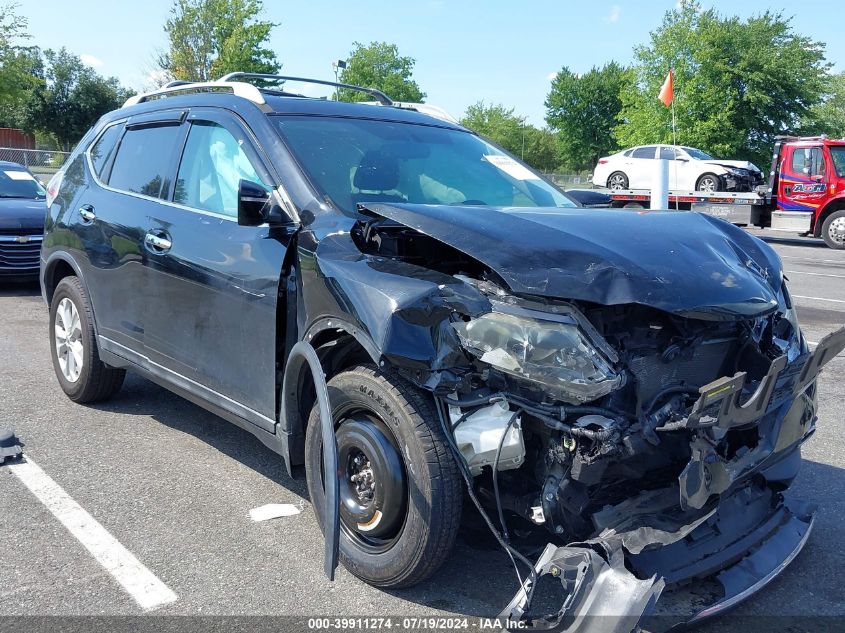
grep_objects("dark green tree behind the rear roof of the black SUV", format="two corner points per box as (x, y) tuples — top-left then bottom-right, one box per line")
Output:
(25, 48), (131, 150)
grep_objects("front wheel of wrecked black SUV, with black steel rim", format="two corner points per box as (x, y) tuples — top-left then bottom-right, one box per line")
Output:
(305, 365), (463, 588)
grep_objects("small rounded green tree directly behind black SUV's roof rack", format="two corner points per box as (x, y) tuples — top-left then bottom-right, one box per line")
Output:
(338, 42), (425, 103)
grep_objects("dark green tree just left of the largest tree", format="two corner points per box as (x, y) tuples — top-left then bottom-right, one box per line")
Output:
(546, 62), (631, 171)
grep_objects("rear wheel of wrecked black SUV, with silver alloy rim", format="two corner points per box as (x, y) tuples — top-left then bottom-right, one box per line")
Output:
(50, 277), (126, 403)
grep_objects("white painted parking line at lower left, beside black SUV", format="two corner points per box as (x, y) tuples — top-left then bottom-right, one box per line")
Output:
(9, 457), (177, 611)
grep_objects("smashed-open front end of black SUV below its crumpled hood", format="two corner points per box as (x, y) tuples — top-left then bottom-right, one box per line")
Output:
(353, 207), (845, 630)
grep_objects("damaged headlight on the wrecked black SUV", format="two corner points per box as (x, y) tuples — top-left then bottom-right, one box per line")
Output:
(453, 312), (624, 404)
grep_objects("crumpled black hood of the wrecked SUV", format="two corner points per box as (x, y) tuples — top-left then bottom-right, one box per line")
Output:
(367, 203), (782, 320)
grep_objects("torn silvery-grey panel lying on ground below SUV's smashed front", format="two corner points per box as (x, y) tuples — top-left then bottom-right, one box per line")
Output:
(499, 543), (664, 633)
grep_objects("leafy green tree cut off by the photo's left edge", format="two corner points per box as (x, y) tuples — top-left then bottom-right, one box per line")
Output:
(0, 4), (42, 127)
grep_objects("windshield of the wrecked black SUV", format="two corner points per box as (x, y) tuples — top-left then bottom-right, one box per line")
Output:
(275, 115), (576, 212)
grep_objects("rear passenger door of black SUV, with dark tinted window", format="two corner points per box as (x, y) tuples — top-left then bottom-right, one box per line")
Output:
(76, 111), (184, 354)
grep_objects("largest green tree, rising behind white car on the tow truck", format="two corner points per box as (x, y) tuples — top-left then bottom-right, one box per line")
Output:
(616, 0), (829, 164)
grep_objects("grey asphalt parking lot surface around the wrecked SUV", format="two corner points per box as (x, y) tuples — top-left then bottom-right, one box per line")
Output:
(0, 231), (845, 631)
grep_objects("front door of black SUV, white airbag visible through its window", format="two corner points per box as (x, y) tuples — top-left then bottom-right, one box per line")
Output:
(145, 109), (294, 430)
